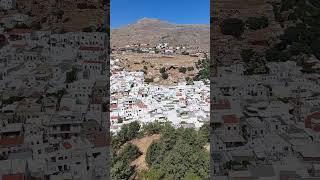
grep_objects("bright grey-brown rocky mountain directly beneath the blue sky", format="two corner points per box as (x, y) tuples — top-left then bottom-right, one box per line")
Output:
(111, 18), (210, 51)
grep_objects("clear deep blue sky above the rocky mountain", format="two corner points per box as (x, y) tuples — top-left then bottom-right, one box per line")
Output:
(110, 0), (210, 28)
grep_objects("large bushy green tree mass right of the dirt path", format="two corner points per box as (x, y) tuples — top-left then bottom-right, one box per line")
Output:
(146, 124), (209, 179)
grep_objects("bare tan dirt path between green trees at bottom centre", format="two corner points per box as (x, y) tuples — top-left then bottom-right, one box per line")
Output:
(130, 134), (160, 172)
